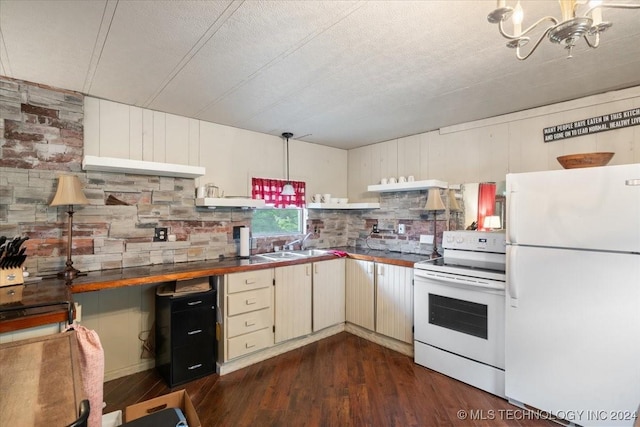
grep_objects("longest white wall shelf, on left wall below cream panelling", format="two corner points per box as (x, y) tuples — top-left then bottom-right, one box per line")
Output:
(82, 156), (205, 178)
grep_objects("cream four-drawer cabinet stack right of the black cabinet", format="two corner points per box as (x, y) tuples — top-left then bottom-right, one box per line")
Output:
(221, 268), (274, 362)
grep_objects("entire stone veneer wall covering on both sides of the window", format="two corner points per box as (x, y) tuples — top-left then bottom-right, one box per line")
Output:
(0, 77), (447, 275)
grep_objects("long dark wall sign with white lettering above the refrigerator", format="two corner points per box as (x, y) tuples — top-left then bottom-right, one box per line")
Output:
(542, 108), (640, 142)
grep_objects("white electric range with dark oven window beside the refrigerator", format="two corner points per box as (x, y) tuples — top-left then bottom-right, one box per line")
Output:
(414, 230), (506, 397)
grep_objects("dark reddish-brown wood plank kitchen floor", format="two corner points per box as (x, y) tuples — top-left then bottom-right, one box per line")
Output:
(104, 332), (558, 427)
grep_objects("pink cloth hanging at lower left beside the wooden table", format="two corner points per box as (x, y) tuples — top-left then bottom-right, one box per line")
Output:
(67, 324), (104, 427)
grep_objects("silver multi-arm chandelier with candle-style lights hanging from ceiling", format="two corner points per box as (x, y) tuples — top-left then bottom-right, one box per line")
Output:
(487, 0), (640, 61)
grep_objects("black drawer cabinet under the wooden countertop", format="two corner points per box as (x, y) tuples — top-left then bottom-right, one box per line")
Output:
(156, 289), (217, 387)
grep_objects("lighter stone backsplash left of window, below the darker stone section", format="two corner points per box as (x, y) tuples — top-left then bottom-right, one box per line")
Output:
(0, 168), (251, 275)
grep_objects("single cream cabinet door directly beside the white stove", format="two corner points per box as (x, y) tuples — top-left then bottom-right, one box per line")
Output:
(376, 264), (413, 343)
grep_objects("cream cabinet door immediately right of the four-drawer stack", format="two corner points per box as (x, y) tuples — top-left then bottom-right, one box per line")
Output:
(275, 263), (313, 343)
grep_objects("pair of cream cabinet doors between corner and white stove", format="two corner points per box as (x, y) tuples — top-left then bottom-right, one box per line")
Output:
(346, 259), (413, 343)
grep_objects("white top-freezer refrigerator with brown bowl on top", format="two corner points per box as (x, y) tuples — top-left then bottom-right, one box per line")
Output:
(505, 164), (640, 426)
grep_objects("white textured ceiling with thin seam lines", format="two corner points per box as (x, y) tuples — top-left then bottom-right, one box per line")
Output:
(0, 0), (640, 148)
